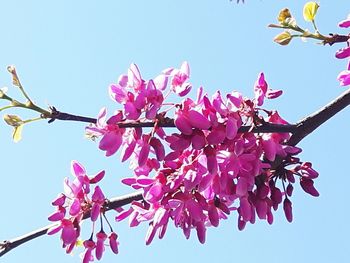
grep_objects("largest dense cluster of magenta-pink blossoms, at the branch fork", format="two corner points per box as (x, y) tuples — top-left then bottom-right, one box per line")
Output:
(87, 62), (318, 244)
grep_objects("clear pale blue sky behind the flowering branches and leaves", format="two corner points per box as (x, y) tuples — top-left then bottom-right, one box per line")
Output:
(0, 0), (350, 263)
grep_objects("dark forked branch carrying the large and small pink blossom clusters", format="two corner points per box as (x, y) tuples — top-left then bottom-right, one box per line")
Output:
(0, 89), (350, 257)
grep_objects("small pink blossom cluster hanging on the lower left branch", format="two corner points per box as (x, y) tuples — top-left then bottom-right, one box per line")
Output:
(48, 161), (118, 263)
